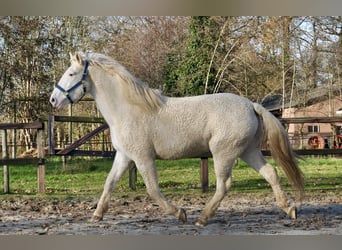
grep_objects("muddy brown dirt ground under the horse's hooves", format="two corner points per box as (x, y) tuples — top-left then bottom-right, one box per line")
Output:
(0, 192), (342, 235)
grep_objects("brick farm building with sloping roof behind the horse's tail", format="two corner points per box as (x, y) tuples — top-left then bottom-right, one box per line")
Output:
(263, 88), (342, 149)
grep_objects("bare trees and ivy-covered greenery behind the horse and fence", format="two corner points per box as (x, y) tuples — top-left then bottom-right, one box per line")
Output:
(0, 16), (342, 151)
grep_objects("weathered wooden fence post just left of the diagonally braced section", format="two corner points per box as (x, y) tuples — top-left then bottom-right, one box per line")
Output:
(37, 129), (45, 193)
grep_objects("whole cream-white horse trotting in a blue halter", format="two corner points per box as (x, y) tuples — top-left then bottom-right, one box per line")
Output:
(50, 53), (304, 226)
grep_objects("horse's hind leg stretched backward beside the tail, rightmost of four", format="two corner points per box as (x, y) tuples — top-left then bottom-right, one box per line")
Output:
(241, 151), (297, 219)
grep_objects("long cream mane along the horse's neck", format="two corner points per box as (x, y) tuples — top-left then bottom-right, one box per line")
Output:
(82, 53), (164, 111)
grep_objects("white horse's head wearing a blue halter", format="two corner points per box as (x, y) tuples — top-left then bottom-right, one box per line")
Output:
(50, 53), (90, 109)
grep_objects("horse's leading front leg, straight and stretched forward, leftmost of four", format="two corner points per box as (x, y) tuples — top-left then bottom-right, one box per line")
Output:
(91, 152), (132, 222)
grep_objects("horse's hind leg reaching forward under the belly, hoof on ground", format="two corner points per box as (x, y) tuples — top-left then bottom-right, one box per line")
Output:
(196, 155), (235, 226)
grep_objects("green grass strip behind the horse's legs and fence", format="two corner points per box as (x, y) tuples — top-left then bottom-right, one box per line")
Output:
(0, 157), (342, 197)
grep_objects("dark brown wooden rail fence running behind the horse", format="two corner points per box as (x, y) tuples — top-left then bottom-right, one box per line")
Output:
(0, 115), (342, 192)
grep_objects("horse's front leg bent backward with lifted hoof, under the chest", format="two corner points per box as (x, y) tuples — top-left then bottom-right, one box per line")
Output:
(136, 160), (187, 223)
